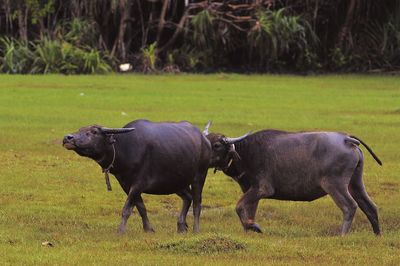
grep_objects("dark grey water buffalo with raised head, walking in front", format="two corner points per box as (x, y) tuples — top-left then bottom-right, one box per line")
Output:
(63, 120), (211, 233)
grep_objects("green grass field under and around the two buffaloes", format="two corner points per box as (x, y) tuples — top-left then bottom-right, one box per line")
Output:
(0, 74), (400, 265)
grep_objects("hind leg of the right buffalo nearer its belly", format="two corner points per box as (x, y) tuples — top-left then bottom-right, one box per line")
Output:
(322, 180), (357, 236)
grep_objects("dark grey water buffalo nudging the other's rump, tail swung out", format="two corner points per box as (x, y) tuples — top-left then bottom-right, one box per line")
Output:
(203, 122), (382, 235)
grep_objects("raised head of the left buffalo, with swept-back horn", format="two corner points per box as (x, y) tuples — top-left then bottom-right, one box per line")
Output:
(63, 125), (134, 160)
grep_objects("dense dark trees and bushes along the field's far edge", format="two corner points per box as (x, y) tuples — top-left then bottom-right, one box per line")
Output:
(0, 0), (400, 73)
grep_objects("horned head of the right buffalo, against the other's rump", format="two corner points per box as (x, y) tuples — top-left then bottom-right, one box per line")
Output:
(203, 121), (251, 170)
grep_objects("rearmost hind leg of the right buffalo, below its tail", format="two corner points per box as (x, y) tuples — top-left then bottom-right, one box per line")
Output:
(349, 160), (381, 235)
